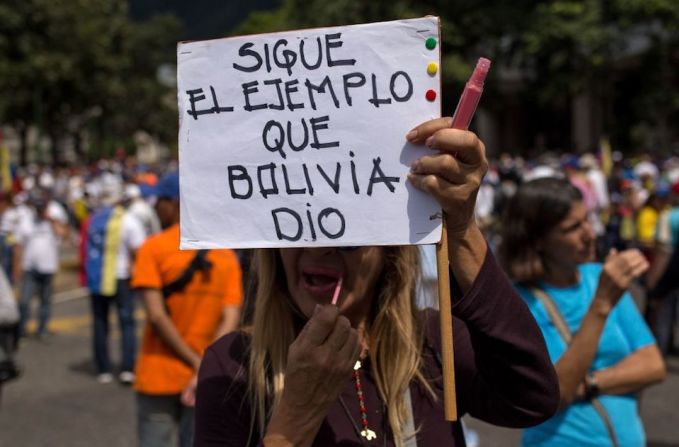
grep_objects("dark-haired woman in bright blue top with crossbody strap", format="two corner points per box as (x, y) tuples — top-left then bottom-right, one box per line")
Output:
(500, 178), (665, 447)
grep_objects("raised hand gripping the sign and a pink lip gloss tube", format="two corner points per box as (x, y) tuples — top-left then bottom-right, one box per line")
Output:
(406, 117), (488, 237)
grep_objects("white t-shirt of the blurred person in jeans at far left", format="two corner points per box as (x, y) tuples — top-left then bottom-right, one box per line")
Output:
(15, 201), (68, 273)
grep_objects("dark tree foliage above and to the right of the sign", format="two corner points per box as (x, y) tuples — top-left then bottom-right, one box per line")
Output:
(235, 0), (679, 152)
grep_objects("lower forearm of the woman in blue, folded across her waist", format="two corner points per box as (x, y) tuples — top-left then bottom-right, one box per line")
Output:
(593, 345), (667, 394)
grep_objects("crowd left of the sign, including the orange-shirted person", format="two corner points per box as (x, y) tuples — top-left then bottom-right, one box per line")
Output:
(0, 160), (243, 446)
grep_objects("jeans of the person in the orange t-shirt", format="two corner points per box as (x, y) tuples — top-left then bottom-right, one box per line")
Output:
(137, 393), (194, 447)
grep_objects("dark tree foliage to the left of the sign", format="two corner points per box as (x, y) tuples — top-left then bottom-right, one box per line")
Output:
(0, 0), (179, 163)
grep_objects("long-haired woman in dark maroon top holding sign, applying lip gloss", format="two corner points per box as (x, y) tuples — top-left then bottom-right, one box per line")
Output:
(195, 118), (559, 447)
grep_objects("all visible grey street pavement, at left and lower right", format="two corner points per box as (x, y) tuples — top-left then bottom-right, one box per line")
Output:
(0, 266), (679, 447)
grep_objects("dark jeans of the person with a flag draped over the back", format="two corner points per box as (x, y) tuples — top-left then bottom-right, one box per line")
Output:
(90, 279), (137, 374)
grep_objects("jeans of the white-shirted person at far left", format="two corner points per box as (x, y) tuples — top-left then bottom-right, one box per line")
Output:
(19, 270), (54, 337)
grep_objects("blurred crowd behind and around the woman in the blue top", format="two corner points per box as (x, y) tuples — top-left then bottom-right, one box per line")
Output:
(476, 152), (679, 355)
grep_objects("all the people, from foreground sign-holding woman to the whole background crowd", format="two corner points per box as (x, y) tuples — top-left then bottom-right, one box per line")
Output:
(0, 141), (679, 446)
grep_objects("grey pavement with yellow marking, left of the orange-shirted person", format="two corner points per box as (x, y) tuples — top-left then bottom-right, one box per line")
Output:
(0, 286), (142, 447)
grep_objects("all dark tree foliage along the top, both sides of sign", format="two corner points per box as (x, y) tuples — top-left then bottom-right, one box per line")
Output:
(0, 0), (679, 162)
